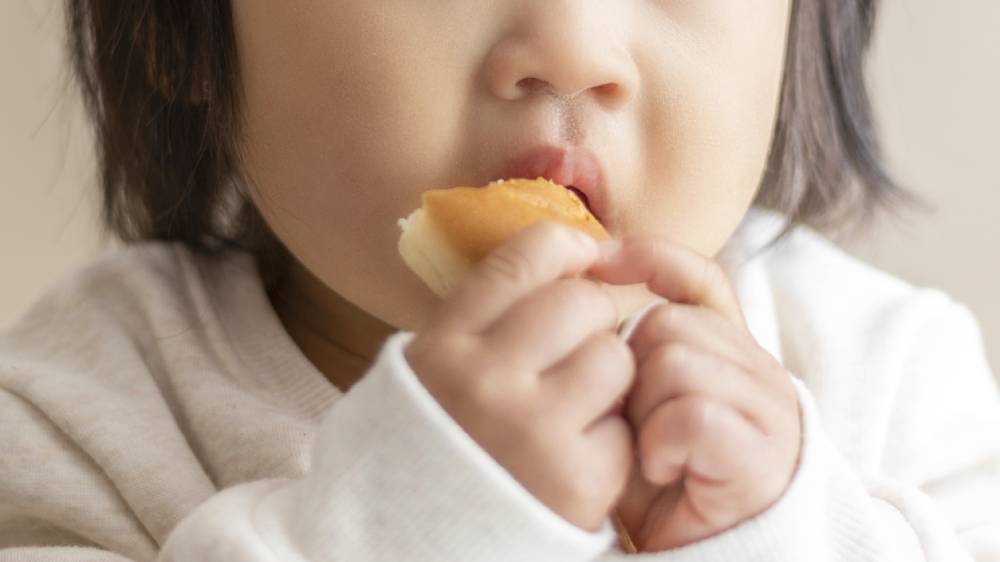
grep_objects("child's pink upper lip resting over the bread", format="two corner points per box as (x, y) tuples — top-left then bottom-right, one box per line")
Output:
(506, 145), (607, 223)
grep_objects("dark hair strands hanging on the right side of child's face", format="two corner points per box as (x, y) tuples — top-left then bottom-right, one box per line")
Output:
(754, 0), (926, 244)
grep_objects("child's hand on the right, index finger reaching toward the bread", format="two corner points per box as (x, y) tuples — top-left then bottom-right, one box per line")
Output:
(591, 238), (801, 552)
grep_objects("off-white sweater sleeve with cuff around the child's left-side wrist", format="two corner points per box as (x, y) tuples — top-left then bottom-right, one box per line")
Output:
(160, 332), (615, 562)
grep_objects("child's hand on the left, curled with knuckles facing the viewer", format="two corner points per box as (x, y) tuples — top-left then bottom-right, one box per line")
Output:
(405, 222), (635, 531)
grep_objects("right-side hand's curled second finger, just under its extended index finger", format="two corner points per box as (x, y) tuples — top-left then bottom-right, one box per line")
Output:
(628, 302), (766, 372)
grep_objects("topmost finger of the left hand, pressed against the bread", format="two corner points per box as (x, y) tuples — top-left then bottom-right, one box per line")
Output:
(434, 220), (597, 333)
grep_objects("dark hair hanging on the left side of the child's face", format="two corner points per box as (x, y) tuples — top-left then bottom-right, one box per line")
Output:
(66, 0), (289, 286)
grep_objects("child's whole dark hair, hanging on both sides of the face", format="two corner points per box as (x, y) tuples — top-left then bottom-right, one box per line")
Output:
(66, 0), (916, 285)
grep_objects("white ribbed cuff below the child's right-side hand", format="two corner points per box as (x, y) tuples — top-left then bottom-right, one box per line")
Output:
(600, 377), (883, 562)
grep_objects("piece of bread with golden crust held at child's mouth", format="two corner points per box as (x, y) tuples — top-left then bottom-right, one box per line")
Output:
(398, 178), (610, 296)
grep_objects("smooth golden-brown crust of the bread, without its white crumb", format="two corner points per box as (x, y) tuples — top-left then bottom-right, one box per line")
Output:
(422, 178), (610, 263)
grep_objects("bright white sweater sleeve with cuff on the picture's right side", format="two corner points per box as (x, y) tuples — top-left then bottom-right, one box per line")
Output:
(600, 303), (1000, 562)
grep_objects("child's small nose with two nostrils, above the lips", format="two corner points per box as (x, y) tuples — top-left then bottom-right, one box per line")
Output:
(485, 0), (638, 107)
